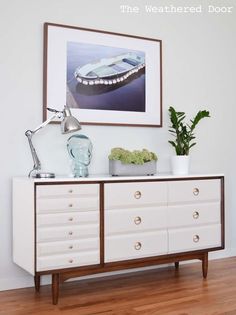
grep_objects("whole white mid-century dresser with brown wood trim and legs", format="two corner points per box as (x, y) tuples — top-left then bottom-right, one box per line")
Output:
(13, 175), (224, 304)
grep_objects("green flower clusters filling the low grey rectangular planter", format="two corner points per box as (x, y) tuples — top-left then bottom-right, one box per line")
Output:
(108, 148), (157, 165)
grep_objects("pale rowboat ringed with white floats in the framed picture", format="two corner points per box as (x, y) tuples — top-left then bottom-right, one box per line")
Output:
(74, 52), (145, 85)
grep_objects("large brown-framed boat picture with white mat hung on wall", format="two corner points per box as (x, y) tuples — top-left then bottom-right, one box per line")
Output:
(43, 23), (162, 127)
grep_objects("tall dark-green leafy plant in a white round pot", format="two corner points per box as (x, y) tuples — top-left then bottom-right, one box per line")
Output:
(169, 106), (210, 175)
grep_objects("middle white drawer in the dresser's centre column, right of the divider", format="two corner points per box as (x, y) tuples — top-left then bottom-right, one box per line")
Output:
(105, 207), (167, 235)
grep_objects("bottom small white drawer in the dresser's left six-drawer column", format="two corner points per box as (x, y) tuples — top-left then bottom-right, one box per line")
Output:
(37, 251), (100, 271)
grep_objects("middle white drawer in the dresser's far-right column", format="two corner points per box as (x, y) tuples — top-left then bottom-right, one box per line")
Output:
(167, 202), (221, 227)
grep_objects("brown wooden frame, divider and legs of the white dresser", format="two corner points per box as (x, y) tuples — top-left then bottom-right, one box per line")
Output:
(17, 176), (225, 304)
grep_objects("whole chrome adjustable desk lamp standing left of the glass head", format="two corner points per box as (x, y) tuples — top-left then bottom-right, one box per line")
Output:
(25, 105), (81, 178)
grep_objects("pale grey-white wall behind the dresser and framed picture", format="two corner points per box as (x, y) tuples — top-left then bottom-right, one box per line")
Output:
(0, 0), (236, 289)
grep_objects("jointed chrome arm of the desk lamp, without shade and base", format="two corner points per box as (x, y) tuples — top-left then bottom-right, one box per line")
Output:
(25, 112), (62, 177)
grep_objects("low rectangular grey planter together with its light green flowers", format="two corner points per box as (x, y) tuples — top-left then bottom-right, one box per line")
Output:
(108, 148), (157, 176)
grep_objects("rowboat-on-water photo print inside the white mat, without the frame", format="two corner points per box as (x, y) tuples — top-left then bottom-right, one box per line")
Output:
(67, 42), (146, 113)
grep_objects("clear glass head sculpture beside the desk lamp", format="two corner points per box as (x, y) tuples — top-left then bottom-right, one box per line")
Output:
(67, 135), (93, 177)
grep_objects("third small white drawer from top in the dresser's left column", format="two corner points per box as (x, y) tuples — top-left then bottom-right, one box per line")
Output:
(37, 211), (99, 227)
